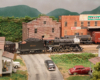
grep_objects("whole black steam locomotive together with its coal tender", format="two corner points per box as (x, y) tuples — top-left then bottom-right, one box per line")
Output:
(18, 38), (82, 53)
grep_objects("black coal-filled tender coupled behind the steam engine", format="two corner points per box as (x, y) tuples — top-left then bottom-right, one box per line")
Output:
(18, 38), (45, 54)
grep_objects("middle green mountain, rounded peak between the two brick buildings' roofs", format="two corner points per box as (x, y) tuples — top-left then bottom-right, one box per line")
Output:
(47, 8), (79, 18)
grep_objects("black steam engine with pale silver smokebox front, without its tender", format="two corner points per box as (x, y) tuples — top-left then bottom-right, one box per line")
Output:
(45, 37), (82, 52)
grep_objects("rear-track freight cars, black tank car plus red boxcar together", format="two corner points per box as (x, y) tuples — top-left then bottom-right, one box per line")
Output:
(63, 31), (100, 44)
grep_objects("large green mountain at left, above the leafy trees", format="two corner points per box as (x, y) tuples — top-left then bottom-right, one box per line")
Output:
(0, 5), (41, 17)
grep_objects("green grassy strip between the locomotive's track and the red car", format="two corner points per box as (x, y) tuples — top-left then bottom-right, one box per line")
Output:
(51, 53), (95, 63)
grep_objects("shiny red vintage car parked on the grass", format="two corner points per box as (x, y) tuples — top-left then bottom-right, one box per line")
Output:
(68, 65), (92, 75)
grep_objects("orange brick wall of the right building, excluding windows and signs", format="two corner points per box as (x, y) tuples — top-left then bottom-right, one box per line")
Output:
(59, 15), (100, 37)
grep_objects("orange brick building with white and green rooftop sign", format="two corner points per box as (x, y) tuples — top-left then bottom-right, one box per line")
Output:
(59, 14), (100, 37)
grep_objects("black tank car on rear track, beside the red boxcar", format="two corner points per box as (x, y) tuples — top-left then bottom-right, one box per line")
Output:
(64, 35), (92, 44)
